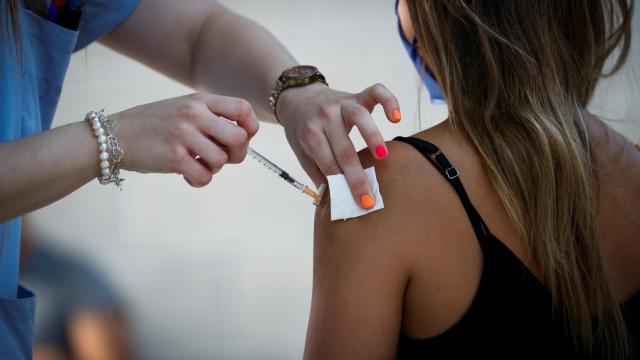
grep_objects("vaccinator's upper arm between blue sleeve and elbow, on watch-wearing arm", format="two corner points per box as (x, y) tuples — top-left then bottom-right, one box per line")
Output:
(100, 0), (222, 82)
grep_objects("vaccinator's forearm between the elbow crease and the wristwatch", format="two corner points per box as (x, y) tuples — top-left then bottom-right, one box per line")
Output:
(192, 6), (297, 121)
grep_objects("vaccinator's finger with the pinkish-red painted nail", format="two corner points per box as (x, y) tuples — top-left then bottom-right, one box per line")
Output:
(340, 103), (389, 159)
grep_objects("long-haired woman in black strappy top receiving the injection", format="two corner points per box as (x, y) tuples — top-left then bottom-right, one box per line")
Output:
(305, 0), (640, 359)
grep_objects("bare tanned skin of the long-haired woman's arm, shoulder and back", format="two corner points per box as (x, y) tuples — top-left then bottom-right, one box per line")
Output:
(304, 2), (640, 359)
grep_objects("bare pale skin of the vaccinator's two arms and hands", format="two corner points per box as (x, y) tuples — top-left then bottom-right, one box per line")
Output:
(0, 0), (399, 223)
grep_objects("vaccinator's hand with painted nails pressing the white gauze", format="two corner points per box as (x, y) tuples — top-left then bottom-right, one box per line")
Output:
(277, 83), (400, 208)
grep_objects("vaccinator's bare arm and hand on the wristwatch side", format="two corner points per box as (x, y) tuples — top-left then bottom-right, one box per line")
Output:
(101, 0), (401, 199)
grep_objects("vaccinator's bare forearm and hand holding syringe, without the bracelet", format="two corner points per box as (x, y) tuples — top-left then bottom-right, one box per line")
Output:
(0, 94), (258, 223)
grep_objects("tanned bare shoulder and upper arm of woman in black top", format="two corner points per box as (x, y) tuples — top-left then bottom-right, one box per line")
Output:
(305, 127), (490, 359)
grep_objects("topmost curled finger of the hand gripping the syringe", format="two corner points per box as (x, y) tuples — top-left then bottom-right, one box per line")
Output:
(196, 94), (259, 139)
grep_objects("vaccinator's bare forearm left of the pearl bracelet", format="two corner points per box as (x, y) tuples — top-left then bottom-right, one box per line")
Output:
(0, 123), (100, 223)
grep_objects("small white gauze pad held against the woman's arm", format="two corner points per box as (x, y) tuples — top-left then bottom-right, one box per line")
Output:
(327, 166), (384, 221)
